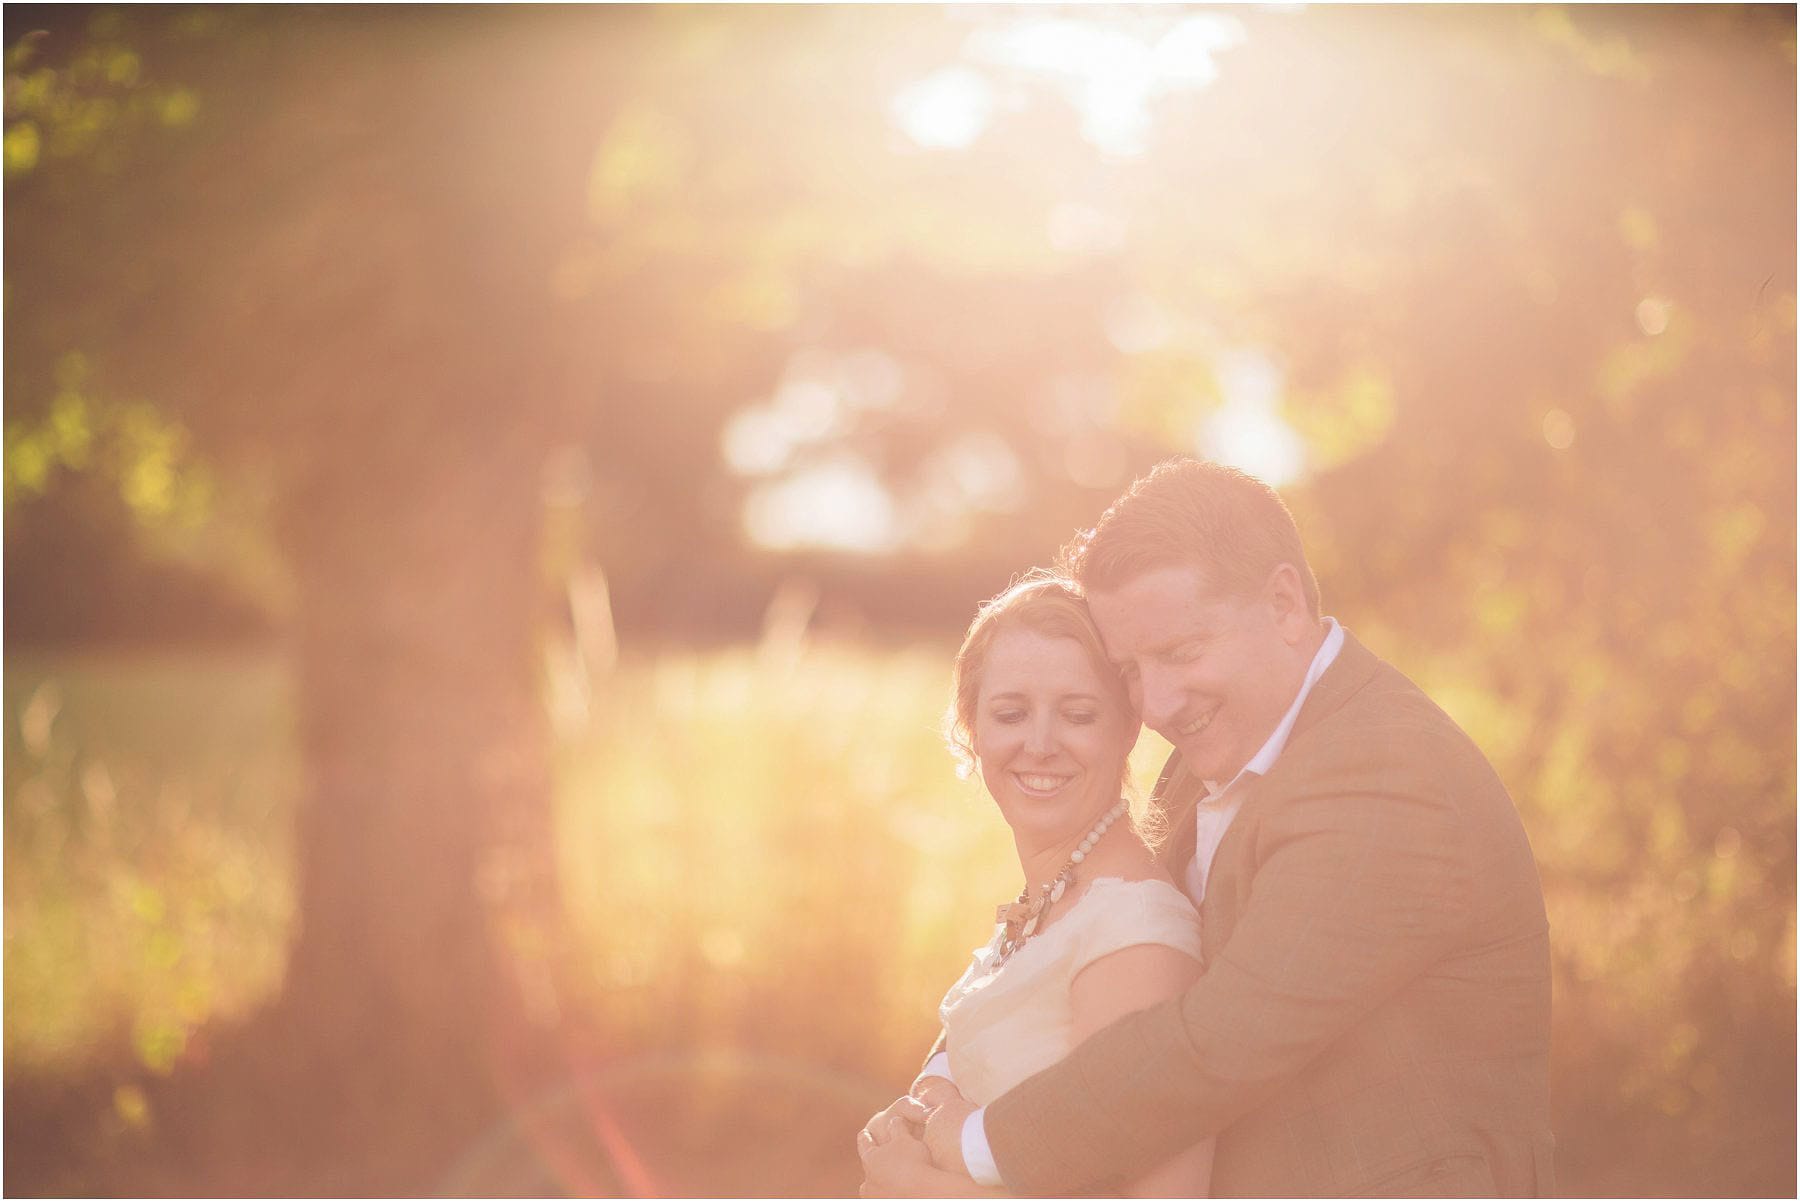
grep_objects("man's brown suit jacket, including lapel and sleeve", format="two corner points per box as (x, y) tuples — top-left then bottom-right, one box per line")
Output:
(985, 637), (1555, 1197)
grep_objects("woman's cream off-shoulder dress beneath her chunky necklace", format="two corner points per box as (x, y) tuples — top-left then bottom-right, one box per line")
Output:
(938, 876), (1201, 1107)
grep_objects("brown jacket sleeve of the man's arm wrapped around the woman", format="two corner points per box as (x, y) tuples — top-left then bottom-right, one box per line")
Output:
(985, 731), (1471, 1195)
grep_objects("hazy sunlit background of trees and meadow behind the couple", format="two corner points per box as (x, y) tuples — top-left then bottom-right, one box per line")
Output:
(4, 5), (1795, 1197)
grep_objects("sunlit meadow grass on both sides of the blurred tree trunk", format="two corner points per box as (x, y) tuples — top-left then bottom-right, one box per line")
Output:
(5, 646), (1166, 1087)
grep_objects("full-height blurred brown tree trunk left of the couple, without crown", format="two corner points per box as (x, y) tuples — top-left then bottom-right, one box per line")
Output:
(216, 22), (592, 1193)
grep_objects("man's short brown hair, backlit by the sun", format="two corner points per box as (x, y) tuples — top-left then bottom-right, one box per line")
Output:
(1058, 459), (1319, 617)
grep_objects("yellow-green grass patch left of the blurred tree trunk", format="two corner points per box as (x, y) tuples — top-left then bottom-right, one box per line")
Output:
(5, 655), (299, 1076)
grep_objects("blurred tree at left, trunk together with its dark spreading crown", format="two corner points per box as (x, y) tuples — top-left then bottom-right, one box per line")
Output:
(7, 9), (662, 1195)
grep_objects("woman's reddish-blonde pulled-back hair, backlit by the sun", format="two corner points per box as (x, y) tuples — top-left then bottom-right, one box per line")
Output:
(943, 569), (1138, 779)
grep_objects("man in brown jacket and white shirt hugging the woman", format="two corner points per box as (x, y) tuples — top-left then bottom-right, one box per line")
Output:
(864, 461), (1553, 1197)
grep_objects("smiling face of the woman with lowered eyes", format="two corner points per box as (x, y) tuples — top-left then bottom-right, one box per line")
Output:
(974, 628), (1138, 842)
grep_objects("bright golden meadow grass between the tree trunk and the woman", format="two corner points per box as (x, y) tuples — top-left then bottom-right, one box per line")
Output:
(558, 646), (1166, 1083)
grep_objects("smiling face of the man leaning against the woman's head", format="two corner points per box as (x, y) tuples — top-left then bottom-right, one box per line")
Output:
(1087, 565), (1319, 783)
